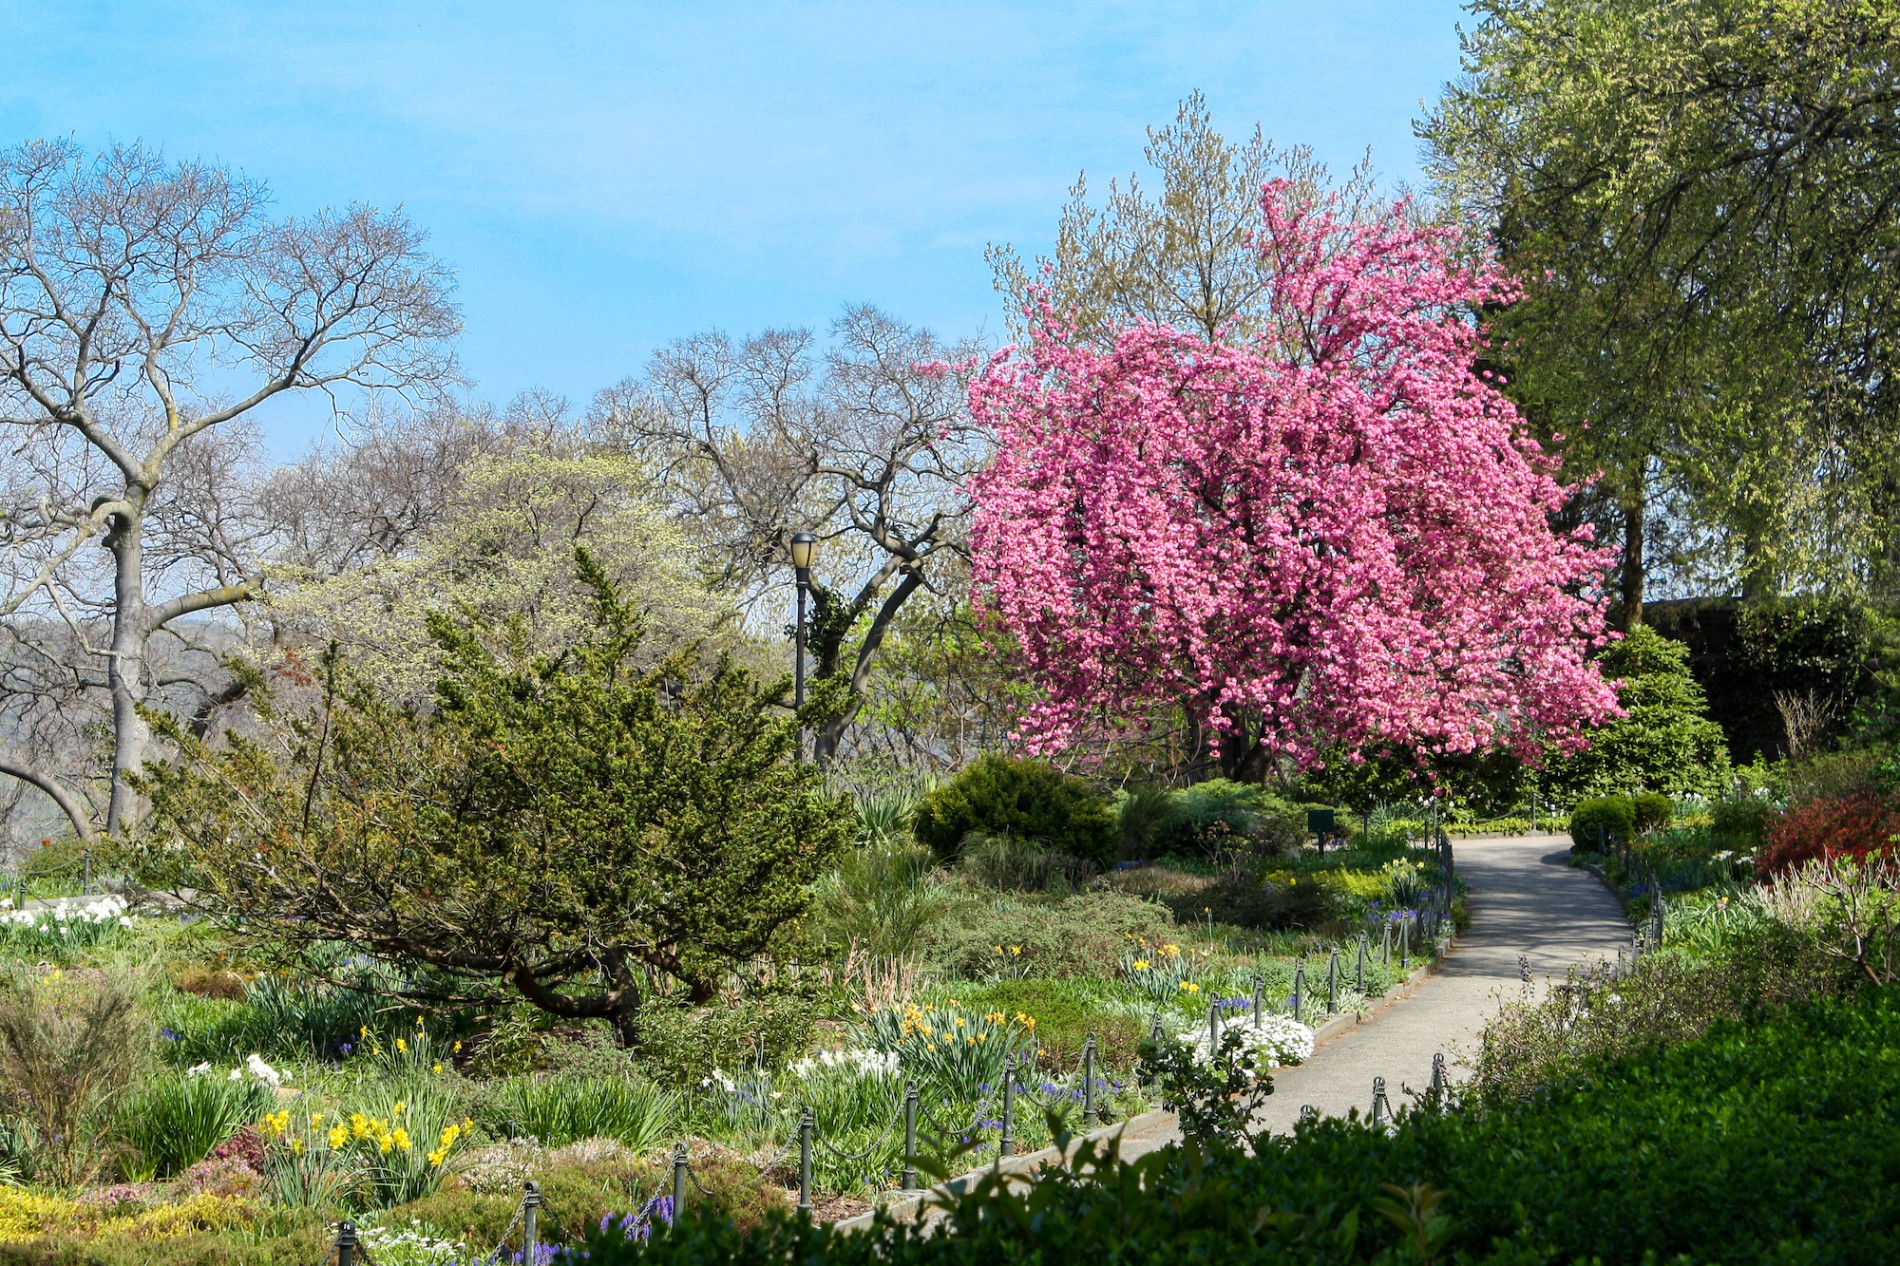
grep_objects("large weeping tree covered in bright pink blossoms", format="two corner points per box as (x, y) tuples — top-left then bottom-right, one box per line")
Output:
(971, 184), (1615, 777)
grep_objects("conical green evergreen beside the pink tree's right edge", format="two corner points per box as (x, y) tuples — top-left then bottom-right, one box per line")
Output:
(1543, 625), (1729, 800)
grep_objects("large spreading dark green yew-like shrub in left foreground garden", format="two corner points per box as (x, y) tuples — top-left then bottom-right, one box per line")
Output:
(127, 553), (853, 1045)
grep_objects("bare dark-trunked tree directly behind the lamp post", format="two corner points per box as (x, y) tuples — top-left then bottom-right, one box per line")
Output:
(593, 306), (986, 758)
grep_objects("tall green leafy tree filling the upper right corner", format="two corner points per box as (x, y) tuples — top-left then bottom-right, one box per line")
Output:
(1419, 0), (1900, 623)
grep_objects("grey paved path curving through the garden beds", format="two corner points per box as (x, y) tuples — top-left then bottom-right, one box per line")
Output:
(1121, 834), (1630, 1158)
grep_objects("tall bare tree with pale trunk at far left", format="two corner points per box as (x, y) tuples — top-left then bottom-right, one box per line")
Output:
(0, 143), (458, 836)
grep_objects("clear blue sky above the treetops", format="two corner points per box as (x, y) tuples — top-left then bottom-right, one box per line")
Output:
(0, 0), (1459, 439)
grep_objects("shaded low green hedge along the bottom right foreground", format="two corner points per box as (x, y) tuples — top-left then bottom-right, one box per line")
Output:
(591, 988), (1900, 1266)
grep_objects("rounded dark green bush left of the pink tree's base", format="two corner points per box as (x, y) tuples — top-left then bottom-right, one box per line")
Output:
(916, 753), (1117, 867)
